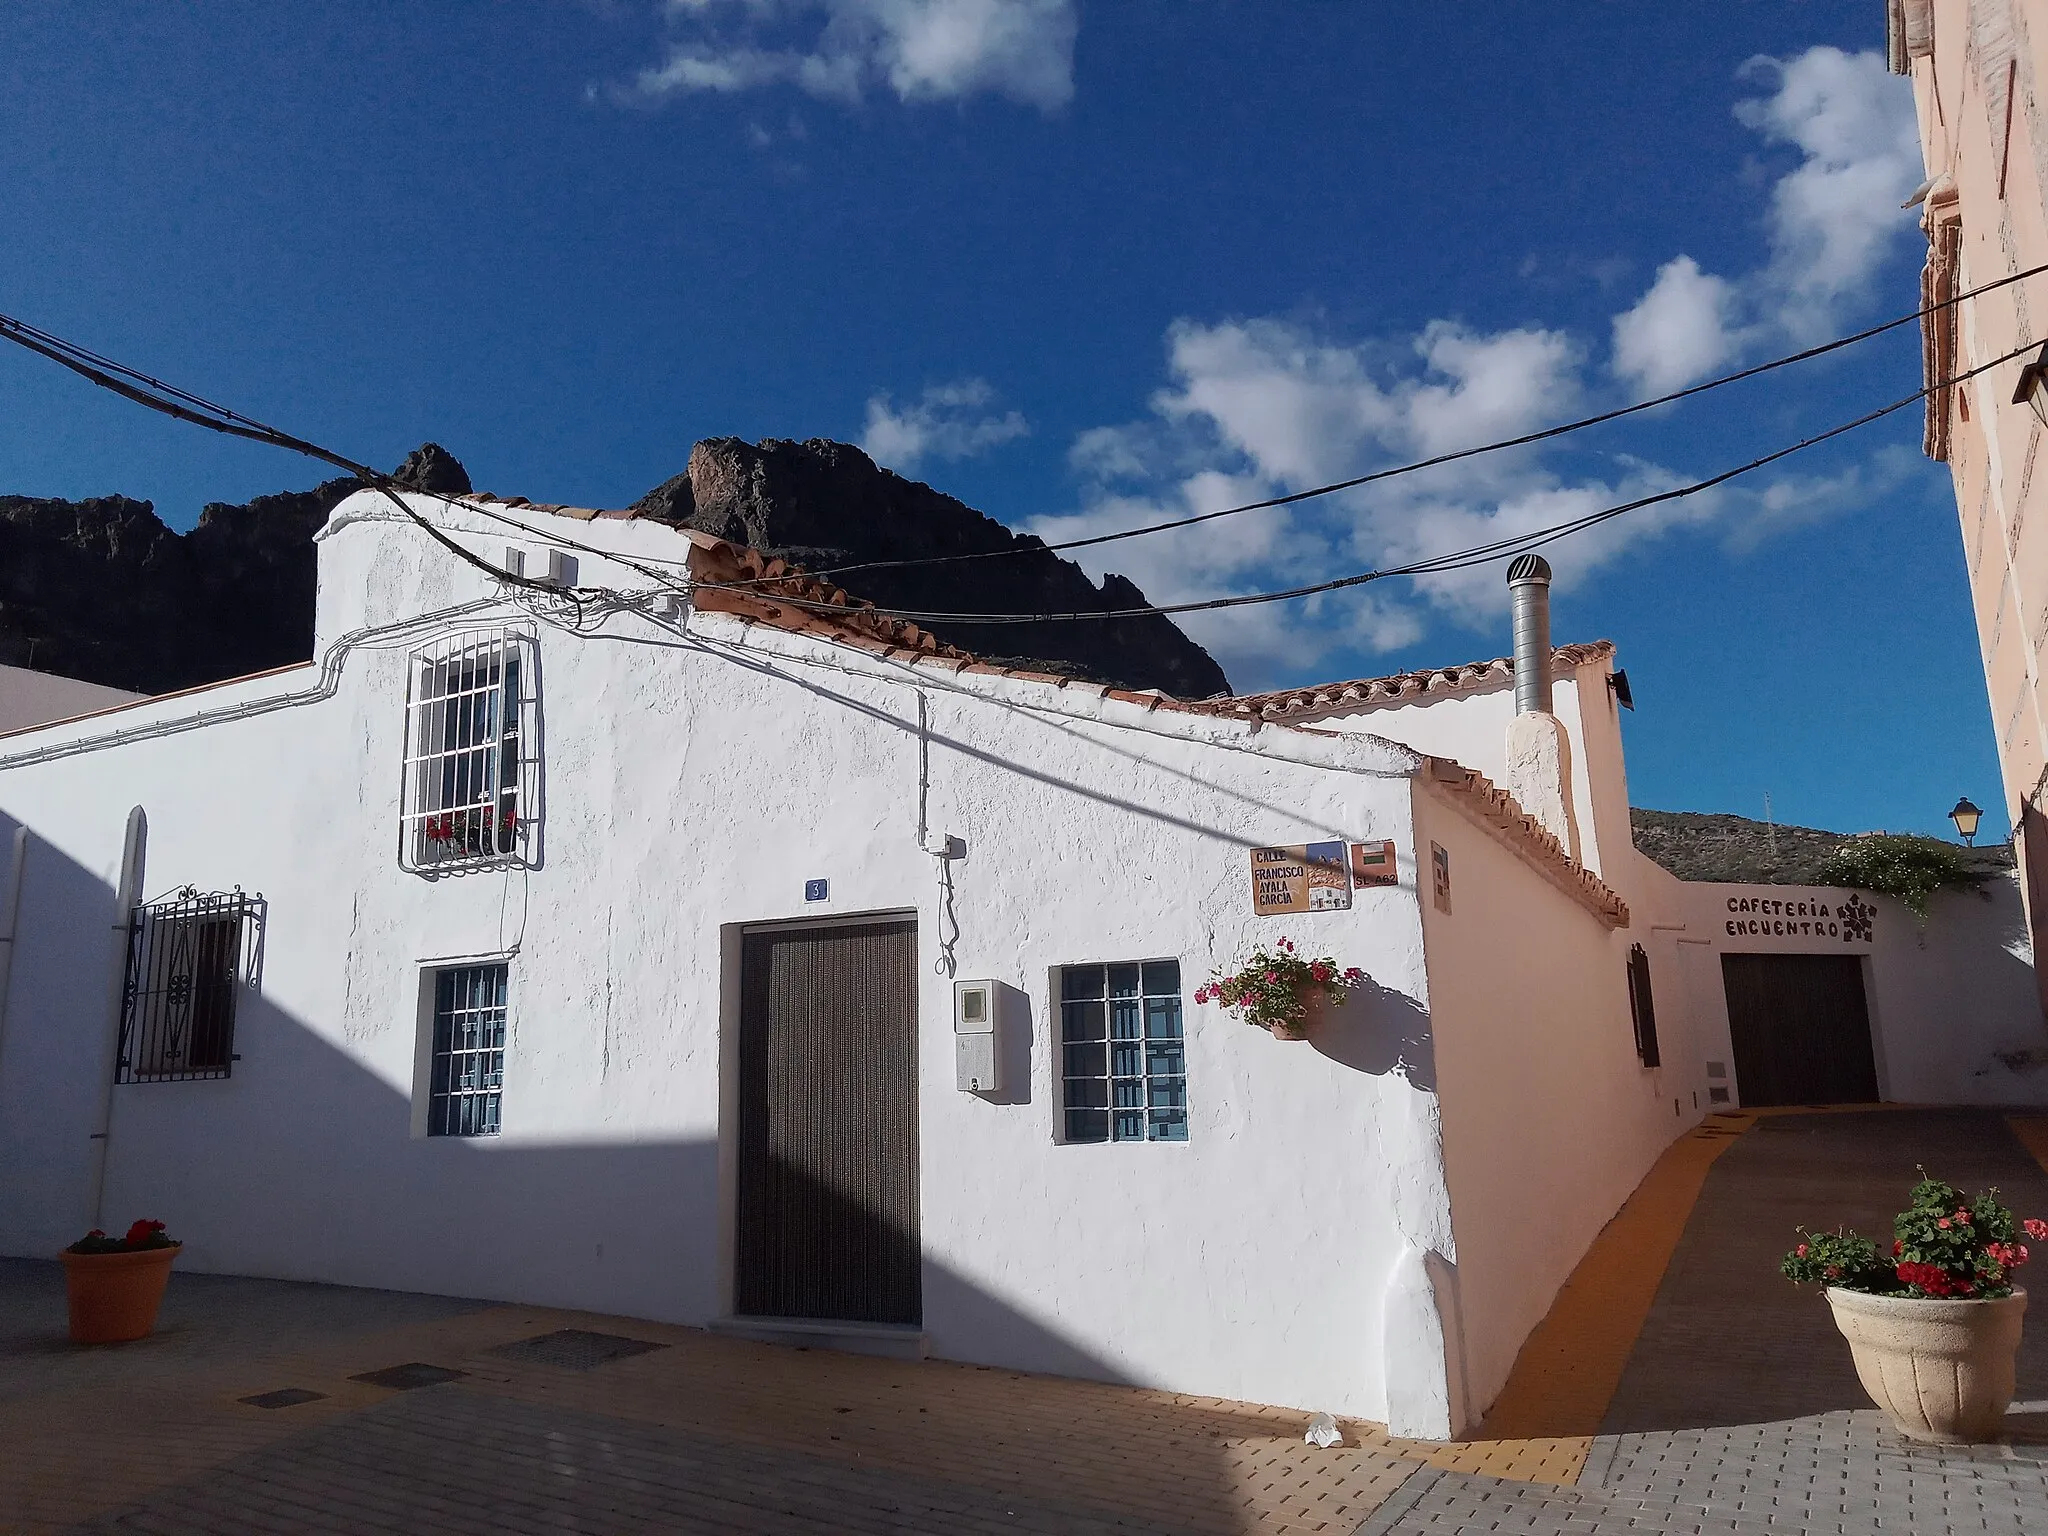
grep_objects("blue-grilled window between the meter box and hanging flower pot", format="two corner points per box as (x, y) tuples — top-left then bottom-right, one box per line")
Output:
(1059, 961), (1188, 1141)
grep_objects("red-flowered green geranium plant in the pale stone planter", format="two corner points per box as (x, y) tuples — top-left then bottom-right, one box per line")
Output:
(1778, 1169), (2048, 1298)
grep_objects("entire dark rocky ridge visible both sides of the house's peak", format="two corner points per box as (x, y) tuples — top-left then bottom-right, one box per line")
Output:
(0, 438), (1229, 698)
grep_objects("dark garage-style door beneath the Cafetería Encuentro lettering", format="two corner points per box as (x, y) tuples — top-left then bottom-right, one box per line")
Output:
(1720, 954), (1878, 1108)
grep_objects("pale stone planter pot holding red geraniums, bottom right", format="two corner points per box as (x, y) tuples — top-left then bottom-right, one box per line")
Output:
(1827, 1288), (2028, 1446)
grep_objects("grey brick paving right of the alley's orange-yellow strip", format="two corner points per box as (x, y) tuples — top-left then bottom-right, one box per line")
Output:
(1364, 1110), (2048, 1536)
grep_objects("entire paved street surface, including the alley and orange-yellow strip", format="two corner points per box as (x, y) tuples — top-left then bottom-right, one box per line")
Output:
(12, 1110), (2048, 1536)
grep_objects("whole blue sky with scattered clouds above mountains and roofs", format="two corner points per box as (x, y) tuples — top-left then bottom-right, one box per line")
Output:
(0, 0), (2003, 831)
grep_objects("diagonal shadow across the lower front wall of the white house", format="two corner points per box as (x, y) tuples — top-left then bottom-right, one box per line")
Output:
(0, 815), (1122, 1382)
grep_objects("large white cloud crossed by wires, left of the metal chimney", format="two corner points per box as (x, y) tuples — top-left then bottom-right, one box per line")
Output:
(1030, 319), (1671, 686)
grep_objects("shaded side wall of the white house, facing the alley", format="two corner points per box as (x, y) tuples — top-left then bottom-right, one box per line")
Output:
(1415, 786), (1700, 1421)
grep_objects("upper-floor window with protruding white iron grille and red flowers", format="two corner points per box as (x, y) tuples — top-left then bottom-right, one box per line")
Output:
(399, 631), (537, 872)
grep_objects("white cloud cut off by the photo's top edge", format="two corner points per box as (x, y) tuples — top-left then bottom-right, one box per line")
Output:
(633, 0), (1077, 113)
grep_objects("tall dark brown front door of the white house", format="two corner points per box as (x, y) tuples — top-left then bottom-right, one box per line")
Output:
(733, 922), (924, 1323)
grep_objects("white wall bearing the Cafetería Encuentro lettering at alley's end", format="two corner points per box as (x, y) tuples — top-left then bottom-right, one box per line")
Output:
(1642, 858), (2048, 1104)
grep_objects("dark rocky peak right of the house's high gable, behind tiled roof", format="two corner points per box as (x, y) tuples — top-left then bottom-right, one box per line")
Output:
(635, 438), (1231, 698)
